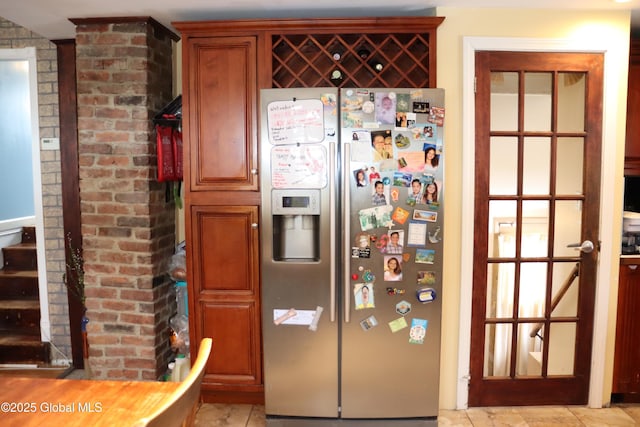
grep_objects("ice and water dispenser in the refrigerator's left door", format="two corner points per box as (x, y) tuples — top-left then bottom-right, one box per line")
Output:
(271, 190), (320, 262)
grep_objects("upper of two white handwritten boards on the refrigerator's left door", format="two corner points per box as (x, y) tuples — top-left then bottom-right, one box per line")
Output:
(267, 99), (324, 145)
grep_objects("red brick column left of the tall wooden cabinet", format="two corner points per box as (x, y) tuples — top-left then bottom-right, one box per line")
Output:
(71, 17), (176, 380)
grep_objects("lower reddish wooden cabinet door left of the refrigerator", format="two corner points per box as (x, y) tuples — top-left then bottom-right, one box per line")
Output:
(189, 206), (262, 392)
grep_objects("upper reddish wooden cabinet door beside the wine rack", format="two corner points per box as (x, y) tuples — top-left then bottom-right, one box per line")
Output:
(183, 37), (258, 191)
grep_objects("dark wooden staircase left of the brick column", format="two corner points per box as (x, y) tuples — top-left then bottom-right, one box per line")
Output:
(0, 227), (49, 365)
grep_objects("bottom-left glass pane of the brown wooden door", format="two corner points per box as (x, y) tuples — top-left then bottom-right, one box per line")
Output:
(483, 324), (511, 377)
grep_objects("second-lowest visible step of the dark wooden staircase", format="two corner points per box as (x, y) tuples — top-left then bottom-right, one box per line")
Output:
(0, 300), (40, 337)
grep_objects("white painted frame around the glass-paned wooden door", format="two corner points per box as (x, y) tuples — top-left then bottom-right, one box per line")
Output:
(456, 37), (628, 409)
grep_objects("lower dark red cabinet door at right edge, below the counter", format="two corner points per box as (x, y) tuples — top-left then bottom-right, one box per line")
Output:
(612, 264), (640, 393)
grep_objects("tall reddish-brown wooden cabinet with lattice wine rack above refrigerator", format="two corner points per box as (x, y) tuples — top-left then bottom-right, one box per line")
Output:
(173, 17), (444, 403)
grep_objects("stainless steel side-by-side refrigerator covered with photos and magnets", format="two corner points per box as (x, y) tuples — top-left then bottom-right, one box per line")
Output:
(260, 88), (445, 426)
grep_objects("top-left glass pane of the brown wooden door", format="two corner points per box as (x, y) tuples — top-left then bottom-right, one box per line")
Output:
(491, 72), (518, 131)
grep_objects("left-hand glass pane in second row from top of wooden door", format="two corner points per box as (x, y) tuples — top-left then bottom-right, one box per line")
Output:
(489, 137), (518, 195)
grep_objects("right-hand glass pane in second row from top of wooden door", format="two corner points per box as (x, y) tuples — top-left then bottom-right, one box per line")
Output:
(556, 138), (584, 195)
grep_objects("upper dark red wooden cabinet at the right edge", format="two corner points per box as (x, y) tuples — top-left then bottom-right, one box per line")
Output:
(624, 39), (640, 175)
